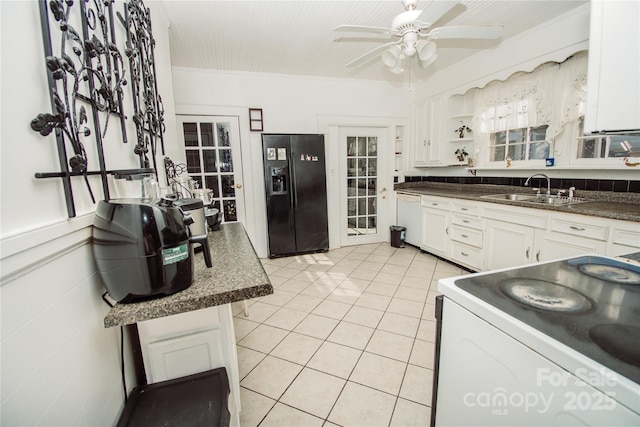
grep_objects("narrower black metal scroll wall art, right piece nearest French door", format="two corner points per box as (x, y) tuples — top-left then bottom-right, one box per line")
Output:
(118, 0), (165, 170)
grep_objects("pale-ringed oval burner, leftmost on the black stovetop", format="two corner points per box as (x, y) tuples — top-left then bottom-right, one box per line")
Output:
(500, 278), (593, 313)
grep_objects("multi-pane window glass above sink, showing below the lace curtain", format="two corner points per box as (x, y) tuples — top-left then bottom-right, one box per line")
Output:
(489, 125), (552, 162)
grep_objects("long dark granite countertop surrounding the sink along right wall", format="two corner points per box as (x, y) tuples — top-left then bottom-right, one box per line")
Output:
(394, 182), (640, 222)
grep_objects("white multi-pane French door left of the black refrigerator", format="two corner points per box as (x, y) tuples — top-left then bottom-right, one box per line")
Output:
(176, 115), (246, 226)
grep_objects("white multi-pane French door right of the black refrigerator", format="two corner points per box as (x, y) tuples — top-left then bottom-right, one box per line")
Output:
(339, 127), (390, 246)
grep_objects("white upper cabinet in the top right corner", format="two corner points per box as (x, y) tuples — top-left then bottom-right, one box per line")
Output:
(584, 0), (640, 133)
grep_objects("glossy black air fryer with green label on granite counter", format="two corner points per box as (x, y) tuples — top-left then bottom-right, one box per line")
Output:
(93, 198), (193, 303)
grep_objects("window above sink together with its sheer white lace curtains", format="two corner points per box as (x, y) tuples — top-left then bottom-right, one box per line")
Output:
(471, 52), (587, 167)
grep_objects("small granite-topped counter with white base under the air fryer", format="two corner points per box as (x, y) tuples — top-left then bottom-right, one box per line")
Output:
(104, 223), (273, 425)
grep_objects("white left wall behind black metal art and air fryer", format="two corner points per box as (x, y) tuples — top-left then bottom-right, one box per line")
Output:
(0, 1), (175, 426)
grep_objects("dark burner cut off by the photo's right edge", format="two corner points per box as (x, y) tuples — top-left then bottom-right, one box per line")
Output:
(589, 323), (640, 368)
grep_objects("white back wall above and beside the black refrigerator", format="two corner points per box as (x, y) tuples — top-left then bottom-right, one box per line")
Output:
(173, 67), (410, 257)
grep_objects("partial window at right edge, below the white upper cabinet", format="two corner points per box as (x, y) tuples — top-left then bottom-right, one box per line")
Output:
(575, 119), (640, 159)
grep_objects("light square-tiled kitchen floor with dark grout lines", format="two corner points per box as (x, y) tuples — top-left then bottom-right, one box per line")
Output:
(233, 243), (465, 427)
